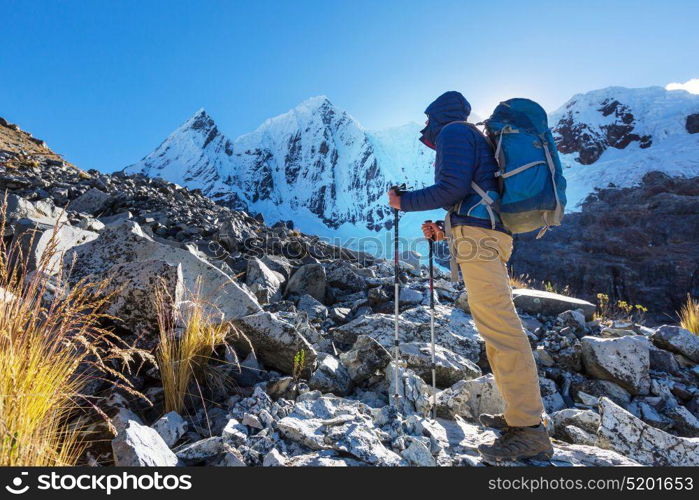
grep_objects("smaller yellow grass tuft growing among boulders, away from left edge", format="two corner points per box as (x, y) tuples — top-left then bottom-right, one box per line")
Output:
(155, 287), (237, 413)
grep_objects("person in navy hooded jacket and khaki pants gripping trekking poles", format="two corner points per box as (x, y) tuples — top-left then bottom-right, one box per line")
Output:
(388, 91), (553, 460)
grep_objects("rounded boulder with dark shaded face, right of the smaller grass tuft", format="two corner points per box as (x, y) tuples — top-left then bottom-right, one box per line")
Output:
(235, 311), (316, 376)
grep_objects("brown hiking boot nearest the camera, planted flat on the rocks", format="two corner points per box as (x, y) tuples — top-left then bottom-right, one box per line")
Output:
(478, 424), (553, 462)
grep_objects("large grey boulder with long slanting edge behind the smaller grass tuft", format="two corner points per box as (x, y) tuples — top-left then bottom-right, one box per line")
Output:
(66, 220), (260, 320)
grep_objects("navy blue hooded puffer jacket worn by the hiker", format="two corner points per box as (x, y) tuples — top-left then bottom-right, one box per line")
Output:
(401, 91), (505, 231)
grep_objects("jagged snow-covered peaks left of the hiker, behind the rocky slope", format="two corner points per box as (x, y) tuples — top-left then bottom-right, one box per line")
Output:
(125, 96), (442, 246)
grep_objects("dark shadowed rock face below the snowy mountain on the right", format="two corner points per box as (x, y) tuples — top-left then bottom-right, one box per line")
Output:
(511, 172), (699, 320)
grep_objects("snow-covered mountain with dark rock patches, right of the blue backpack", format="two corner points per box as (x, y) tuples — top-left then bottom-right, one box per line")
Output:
(549, 87), (699, 206)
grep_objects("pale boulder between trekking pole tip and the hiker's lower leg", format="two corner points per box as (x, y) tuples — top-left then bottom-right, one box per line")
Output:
(437, 374), (505, 422)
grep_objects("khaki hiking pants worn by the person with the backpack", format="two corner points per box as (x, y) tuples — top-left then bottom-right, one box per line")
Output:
(452, 226), (544, 427)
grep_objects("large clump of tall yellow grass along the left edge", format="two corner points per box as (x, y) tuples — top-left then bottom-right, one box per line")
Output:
(0, 198), (116, 466)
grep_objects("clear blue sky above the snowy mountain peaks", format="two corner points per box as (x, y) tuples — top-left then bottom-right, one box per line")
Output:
(0, 0), (699, 171)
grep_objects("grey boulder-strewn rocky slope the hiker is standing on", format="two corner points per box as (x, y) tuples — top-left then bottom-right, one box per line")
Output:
(0, 115), (699, 466)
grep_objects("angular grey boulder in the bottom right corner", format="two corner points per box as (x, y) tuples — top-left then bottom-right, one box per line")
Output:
(597, 398), (699, 467)
